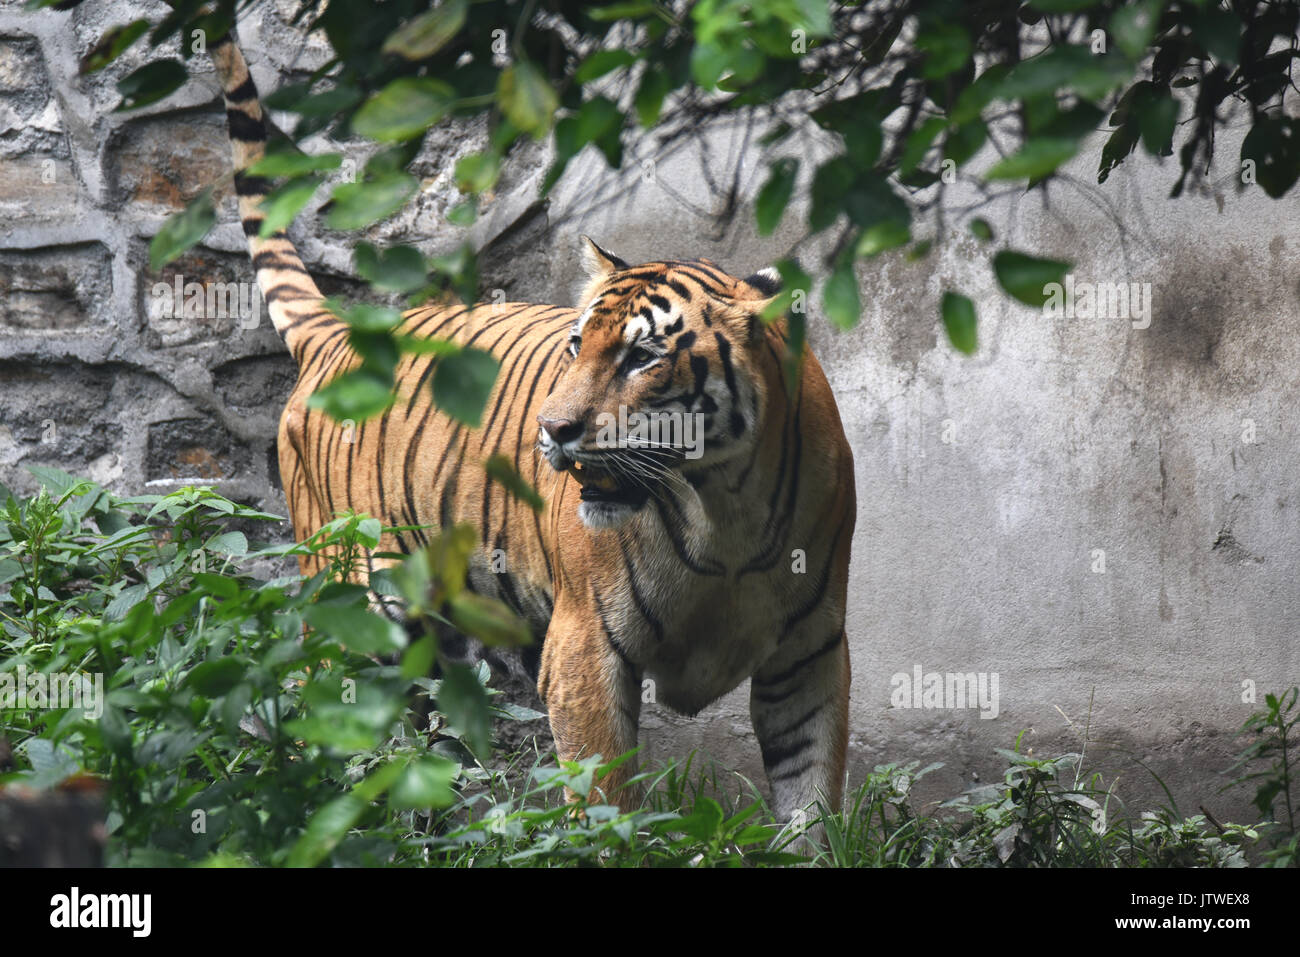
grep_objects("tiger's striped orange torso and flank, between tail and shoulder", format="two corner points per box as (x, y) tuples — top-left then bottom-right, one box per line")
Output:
(280, 303), (576, 636)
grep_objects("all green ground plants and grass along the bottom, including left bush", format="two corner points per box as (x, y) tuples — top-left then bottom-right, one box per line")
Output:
(0, 467), (1297, 867)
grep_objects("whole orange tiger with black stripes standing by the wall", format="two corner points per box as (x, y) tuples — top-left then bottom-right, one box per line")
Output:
(209, 29), (855, 820)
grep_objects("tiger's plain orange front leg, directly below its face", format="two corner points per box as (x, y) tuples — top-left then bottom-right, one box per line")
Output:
(537, 607), (642, 811)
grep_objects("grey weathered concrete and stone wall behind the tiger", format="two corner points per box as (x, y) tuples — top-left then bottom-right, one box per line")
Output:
(0, 0), (1300, 818)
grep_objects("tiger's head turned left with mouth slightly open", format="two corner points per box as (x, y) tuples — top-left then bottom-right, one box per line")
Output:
(537, 237), (780, 528)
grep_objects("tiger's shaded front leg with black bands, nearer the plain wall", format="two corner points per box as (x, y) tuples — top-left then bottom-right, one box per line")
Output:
(749, 623), (849, 822)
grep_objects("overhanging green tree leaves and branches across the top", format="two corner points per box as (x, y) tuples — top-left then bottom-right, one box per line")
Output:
(55, 0), (1300, 374)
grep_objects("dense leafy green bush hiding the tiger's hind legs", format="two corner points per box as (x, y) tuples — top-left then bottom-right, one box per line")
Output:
(0, 468), (527, 863)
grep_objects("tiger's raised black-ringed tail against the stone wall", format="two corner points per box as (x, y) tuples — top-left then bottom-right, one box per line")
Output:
(209, 34), (330, 364)
